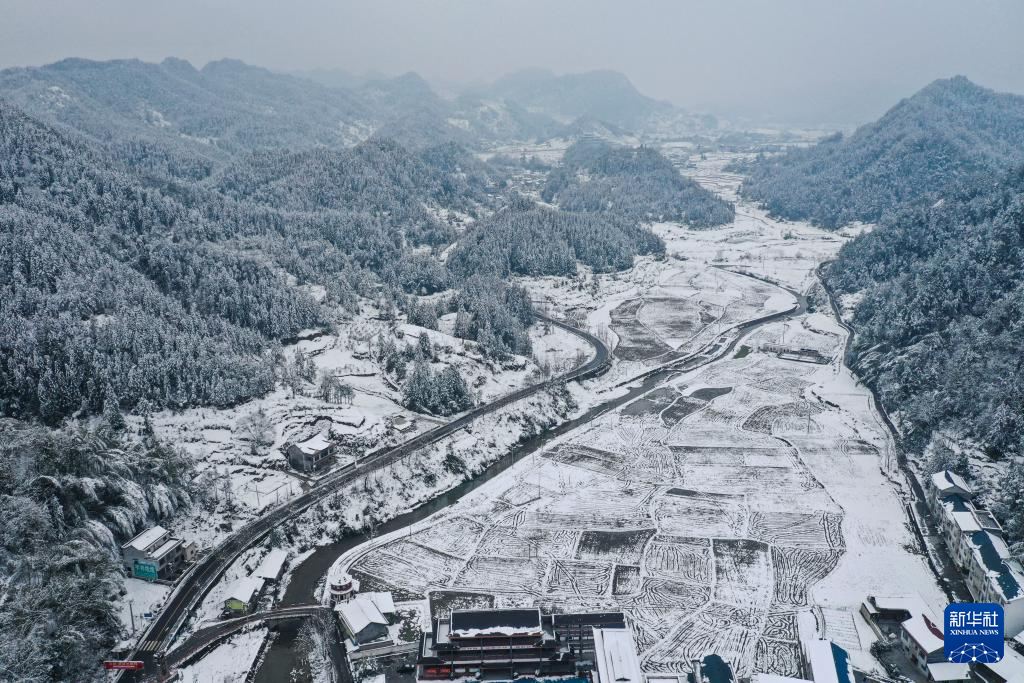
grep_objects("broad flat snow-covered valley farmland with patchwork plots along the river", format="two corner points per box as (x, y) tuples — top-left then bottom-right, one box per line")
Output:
(319, 157), (944, 676)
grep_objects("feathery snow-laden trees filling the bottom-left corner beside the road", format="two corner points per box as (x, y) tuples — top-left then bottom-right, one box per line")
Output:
(0, 420), (194, 681)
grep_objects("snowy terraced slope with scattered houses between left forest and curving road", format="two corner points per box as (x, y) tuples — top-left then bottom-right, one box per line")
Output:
(151, 307), (591, 547)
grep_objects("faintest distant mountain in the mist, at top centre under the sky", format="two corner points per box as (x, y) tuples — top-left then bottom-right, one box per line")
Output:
(469, 69), (673, 128)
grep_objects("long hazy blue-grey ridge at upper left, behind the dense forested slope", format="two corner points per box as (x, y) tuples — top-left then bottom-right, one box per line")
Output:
(0, 58), (371, 155)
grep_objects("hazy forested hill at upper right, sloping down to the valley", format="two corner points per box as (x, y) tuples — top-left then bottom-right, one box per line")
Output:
(741, 76), (1024, 228)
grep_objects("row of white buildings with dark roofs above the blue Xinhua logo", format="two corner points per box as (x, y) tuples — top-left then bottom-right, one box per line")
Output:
(928, 470), (1024, 638)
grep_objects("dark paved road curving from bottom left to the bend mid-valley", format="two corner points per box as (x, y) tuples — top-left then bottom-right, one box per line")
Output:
(124, 314), (611, 681)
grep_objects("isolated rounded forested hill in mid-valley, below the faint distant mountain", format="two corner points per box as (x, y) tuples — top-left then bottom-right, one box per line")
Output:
(542, 140), (734, 227)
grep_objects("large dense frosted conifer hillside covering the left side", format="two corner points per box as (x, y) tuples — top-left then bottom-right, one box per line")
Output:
(0, 105), (507, 422)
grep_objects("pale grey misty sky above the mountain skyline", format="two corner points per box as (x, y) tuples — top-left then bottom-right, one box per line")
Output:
(0, 0), (1024, 123)
